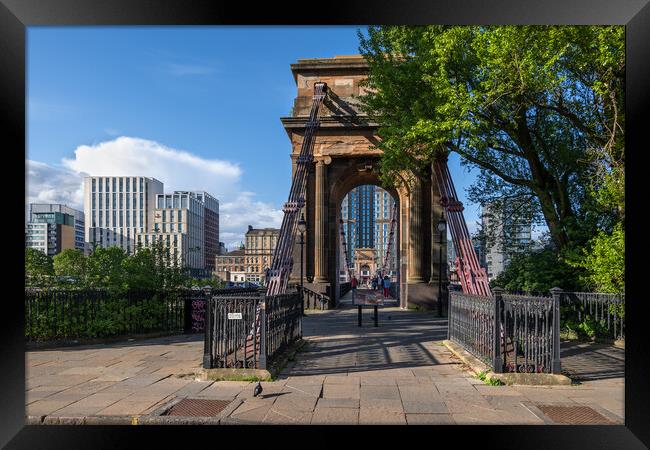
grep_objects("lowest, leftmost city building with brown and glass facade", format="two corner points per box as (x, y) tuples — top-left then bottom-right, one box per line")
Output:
(28, 203), (87, 253)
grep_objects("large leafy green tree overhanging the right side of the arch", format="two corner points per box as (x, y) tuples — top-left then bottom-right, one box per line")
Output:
(359, 26), (625, 253)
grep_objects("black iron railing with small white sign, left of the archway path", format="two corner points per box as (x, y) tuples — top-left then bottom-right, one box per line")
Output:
(203, 291), (302, 369)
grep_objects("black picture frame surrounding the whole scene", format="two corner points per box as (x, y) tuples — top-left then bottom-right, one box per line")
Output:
(0, 0), (650, 450)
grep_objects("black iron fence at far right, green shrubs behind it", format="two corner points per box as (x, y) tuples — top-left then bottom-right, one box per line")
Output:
(551, 289), (625, 340)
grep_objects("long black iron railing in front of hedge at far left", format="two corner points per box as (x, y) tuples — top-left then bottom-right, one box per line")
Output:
(25, 288), (185, 342)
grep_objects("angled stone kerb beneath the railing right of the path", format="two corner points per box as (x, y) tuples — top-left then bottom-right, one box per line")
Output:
(443, 340), (571, 386)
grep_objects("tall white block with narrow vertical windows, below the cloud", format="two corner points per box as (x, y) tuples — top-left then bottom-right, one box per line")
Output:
(84, 177), (163, 253)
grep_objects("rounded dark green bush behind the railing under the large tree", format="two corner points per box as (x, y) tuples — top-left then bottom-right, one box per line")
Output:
(490, 248), (582, 293)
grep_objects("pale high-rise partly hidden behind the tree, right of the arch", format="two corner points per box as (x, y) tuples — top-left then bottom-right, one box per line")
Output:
(481, 202), (532, 280)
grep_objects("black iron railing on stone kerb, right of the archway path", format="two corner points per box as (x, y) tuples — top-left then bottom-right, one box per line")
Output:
(448, 288), (560, 373)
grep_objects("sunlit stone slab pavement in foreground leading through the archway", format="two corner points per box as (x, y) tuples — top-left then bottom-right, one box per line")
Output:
(26, 307), (624, 424)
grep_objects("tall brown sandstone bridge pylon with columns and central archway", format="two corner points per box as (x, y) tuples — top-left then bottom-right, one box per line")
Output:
(281, 55), (447, 309)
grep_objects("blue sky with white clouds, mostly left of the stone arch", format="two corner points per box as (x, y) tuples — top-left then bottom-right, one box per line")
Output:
(27, 26), (479, 245)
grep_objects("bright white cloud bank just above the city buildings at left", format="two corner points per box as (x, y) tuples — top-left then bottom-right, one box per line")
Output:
(27, 136), (283, 247)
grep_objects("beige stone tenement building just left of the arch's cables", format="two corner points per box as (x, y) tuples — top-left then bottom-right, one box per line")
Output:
(244, 225), (280, 284)
